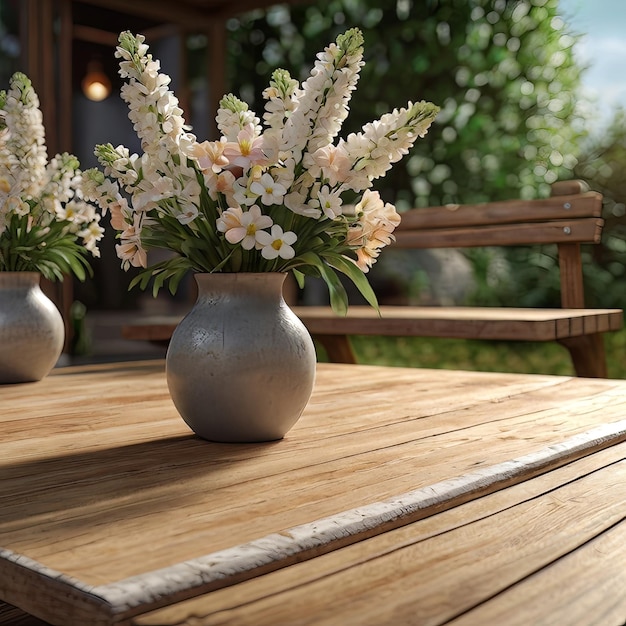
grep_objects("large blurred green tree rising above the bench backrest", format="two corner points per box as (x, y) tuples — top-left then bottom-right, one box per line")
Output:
(228, 0), (585, 210)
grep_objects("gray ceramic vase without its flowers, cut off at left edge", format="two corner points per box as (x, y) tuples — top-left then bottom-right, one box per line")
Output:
(0, 272), (65, 384)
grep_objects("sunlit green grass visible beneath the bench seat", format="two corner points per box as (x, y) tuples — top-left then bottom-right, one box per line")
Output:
(320, 329), (626, 379)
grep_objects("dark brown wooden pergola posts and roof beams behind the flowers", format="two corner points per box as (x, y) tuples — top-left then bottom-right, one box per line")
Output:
(16, 0), (310, 337)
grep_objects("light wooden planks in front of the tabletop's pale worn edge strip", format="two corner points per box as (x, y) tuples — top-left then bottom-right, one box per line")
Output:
(131, 444), (626, 626)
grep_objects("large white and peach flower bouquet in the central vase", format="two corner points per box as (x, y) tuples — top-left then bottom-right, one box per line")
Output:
(84, 29), (439, 313)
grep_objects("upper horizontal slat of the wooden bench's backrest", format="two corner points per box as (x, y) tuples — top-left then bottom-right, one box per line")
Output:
(396, 192), (602, 233)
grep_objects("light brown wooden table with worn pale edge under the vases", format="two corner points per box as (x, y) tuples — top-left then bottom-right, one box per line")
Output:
(0, 361), (626, 626)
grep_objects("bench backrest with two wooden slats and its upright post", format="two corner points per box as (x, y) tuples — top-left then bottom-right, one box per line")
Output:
(393, 181), (604, 308)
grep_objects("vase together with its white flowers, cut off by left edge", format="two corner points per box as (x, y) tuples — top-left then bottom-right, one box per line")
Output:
(0, 72), (104, 383)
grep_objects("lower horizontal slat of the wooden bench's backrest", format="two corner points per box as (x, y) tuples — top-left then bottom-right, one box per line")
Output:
(391, 218), (603, 249)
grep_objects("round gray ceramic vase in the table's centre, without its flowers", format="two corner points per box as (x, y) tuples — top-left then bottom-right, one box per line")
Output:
(166, 272), (316, 443)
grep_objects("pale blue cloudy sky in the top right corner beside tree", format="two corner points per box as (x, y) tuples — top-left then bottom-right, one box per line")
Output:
(559, 0), (626, 126)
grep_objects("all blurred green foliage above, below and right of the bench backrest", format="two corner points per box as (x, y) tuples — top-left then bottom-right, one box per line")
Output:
(222, 0), (626, 308)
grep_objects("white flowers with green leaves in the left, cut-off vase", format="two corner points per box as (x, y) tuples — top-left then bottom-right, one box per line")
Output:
(0, 72), (104, 280)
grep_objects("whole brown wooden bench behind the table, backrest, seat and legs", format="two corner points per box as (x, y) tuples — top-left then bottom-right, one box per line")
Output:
(122, 181), (623, 377)
